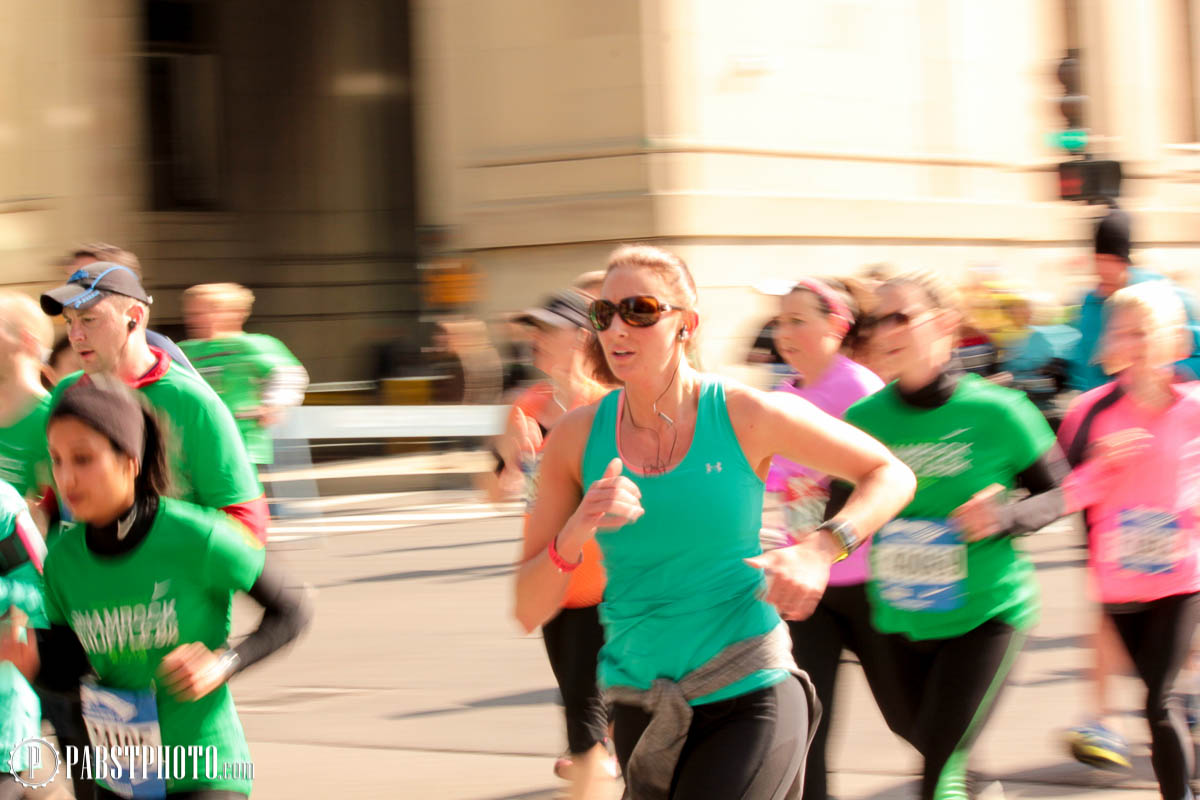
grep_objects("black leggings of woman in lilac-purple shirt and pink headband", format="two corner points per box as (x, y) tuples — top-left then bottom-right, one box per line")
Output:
(787, 584), (908, 800)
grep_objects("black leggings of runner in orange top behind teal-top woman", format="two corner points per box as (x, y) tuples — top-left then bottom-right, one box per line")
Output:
(541, 606), (608, 753)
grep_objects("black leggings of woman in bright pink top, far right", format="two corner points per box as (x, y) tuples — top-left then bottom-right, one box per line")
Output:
(1109, 594), (1200, 800)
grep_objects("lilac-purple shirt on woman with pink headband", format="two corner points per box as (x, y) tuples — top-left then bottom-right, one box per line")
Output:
(767, 354), (883, 587)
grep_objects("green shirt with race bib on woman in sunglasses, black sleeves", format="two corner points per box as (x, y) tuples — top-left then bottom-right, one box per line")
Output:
(846, 374), (1055, 639)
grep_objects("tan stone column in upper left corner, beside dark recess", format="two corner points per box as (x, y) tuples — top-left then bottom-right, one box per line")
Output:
(0, 0), (144, 293)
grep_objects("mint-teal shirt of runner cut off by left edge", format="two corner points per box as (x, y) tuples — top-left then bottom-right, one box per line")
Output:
(0, 481), (46, 771)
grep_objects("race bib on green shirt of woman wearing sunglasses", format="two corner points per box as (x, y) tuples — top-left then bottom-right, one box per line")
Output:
(871, 519), (967, 612)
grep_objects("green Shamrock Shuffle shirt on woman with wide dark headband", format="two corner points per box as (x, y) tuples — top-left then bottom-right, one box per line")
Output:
(44, 498), (265, 794)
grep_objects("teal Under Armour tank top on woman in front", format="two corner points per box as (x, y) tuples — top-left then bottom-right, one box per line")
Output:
(582, 375), (788, 705)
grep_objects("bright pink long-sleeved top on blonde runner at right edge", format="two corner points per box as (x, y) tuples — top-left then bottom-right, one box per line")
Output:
(1058, 383), (1200, 603)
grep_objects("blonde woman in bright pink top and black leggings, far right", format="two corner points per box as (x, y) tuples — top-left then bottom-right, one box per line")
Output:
(1060, 282), (1200, 800)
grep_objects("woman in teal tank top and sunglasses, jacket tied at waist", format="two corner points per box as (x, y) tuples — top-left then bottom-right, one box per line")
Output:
(516, 246), (914, 800)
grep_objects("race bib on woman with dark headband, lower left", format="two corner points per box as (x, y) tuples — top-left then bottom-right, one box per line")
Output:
(79, 681), (167, 800)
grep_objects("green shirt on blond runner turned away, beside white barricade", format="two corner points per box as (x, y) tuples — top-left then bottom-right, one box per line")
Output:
(179, 333), (300, 464)
